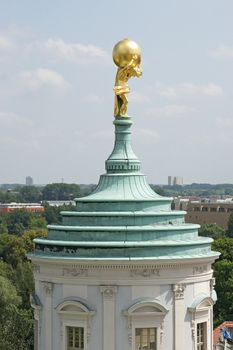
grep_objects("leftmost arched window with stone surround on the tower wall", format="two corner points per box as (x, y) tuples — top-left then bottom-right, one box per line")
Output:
(56, 300), (95, 350)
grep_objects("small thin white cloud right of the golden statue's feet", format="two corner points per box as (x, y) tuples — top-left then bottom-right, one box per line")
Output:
(148, 105), (195, 117)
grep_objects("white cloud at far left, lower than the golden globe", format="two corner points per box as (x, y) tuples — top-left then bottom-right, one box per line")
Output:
(19, 68), (69, 90)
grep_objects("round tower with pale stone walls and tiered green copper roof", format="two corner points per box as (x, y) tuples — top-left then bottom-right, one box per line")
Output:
(29, 39), (218, 350)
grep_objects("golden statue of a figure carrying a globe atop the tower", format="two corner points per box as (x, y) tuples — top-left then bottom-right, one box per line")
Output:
(112, 39), (142, 117)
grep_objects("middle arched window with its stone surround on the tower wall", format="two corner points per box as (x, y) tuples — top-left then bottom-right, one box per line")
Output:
(123, 299), (168, 350)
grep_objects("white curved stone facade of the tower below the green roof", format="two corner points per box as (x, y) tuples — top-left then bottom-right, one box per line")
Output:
(31, 257), (215, 350)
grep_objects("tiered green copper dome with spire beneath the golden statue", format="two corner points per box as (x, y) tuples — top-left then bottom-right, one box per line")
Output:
(29, 117), (219, 261)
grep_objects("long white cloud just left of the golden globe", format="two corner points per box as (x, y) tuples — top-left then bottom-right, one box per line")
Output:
(42, 38), (109, 63)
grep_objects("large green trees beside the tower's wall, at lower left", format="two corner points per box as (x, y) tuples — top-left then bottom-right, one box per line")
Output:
(0, 228), (47, 350)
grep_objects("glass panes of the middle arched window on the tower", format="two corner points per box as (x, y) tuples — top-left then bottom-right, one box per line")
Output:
(135, 328), (157, 350)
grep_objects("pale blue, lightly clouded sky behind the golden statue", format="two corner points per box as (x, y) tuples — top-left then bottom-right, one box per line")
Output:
(0, 0), (233, 184)
